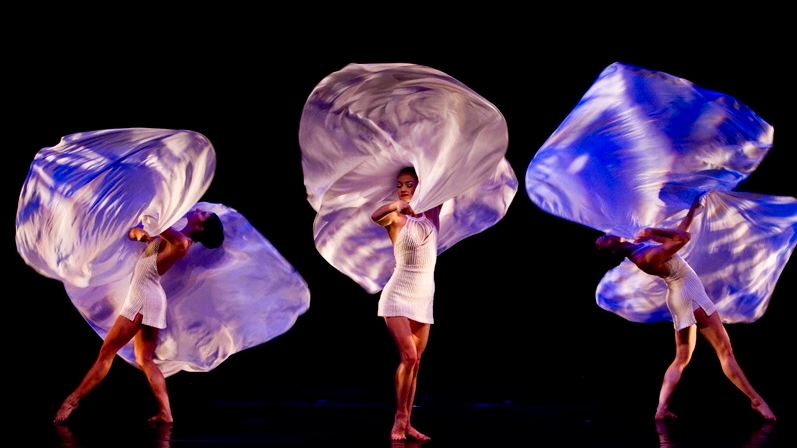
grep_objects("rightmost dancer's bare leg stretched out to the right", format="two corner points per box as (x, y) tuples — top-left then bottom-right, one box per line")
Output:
(695, 308), (776, 422)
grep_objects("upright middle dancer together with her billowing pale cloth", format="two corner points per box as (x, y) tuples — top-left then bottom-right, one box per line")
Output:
(299, 63), (518, 443)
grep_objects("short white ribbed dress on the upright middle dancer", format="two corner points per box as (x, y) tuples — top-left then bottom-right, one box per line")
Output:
(377, 215), (437, 324)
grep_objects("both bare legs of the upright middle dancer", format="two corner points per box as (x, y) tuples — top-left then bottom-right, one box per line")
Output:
(385, 317), (430, 440)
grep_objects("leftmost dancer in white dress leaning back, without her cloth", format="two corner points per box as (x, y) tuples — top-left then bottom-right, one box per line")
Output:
(54, 208), (224, 424)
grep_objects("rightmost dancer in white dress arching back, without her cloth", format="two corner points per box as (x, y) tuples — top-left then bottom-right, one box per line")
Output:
(595, 195), (776, 422)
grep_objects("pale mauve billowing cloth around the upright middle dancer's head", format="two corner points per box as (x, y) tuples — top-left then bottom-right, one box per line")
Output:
(299, 63), (518, 294)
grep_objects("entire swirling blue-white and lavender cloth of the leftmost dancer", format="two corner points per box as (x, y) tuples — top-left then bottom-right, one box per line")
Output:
(17, 128), (310, 376)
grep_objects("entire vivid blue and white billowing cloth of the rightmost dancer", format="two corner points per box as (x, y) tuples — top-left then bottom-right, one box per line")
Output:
(526, 63), (797, 323)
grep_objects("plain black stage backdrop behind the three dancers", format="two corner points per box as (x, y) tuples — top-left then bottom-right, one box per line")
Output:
(9, 17), (797, 424)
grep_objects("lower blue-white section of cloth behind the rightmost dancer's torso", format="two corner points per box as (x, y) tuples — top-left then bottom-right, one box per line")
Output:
(596, 190), (797, 323)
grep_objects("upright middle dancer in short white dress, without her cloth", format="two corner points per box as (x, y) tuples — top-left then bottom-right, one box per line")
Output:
(371, 167), (441, 441)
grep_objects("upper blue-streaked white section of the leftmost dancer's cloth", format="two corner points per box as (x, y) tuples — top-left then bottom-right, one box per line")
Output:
(16, 128), (216, 287)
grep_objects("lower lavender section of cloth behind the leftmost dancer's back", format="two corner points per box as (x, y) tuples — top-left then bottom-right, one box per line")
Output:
(66, 202), (310, 376)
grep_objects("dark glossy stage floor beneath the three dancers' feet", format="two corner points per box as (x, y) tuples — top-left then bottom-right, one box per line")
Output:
(26, 393), (795, 448)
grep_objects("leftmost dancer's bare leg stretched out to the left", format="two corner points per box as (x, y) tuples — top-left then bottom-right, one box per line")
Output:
(54, 314), (141, 423)
